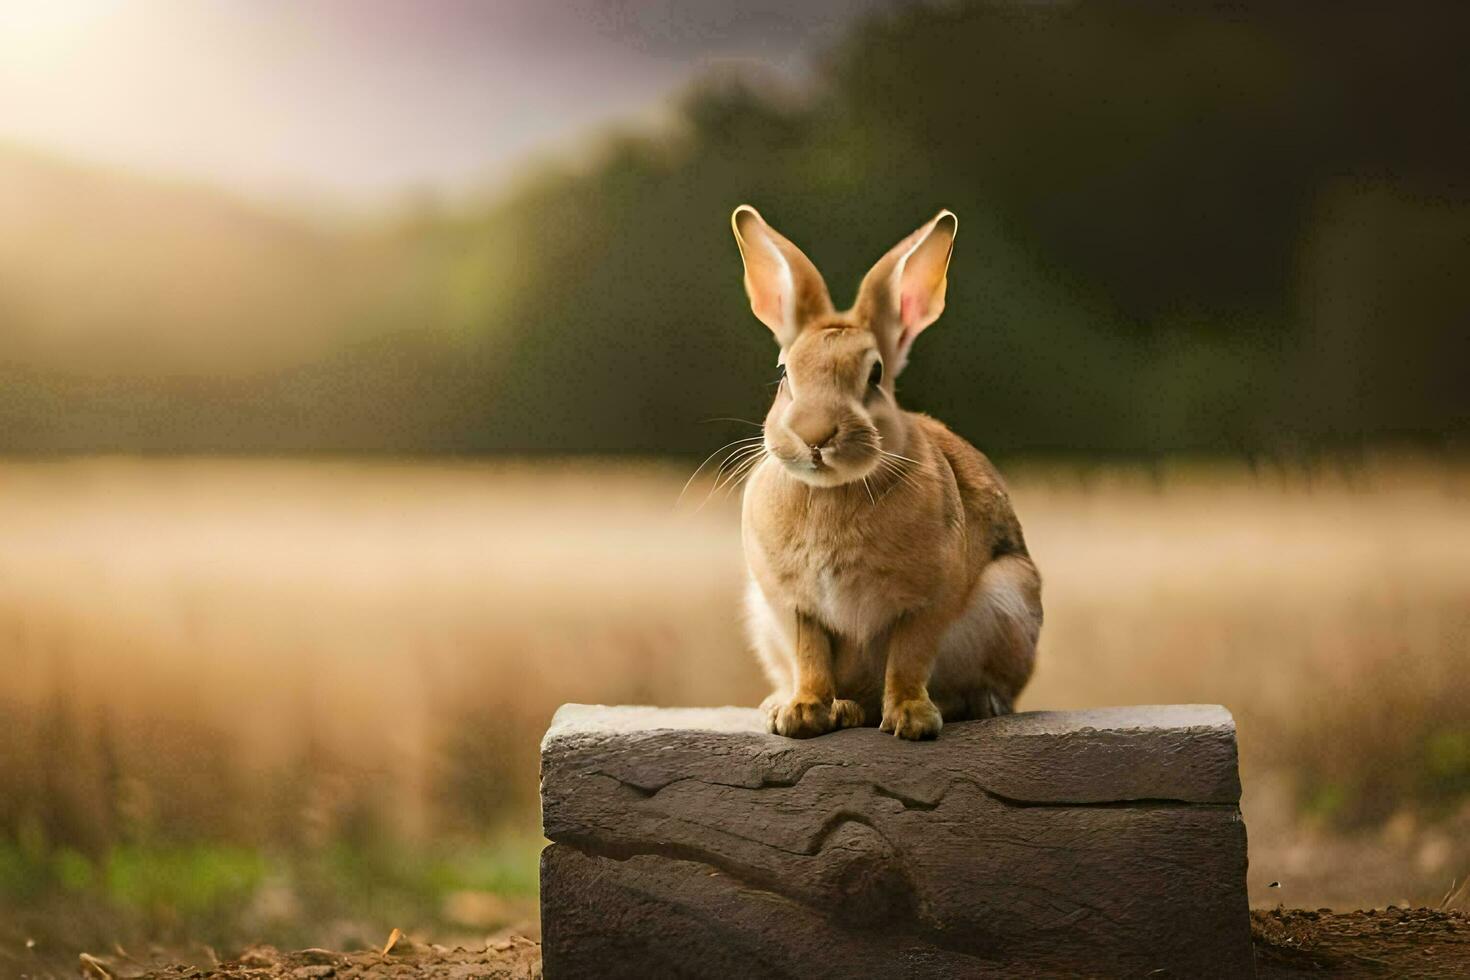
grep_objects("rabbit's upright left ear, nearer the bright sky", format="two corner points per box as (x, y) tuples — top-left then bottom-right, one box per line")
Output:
(731, 204), (832, 347)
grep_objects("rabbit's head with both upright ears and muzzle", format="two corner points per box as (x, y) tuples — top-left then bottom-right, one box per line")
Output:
(731, 204), (958, 486)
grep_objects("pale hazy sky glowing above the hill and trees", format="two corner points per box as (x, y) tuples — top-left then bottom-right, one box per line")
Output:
(0, 0), (889, 197)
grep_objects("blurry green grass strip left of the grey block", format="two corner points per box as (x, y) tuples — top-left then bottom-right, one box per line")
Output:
(0, 835), (542, 949)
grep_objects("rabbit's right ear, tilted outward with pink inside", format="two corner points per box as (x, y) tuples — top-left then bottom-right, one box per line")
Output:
(856, 210), (960, 369)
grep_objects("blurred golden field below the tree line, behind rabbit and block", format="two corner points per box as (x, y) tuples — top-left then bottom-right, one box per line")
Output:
(0, 458), (1470, 962)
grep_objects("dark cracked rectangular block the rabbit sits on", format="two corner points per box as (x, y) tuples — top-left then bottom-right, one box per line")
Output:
(541, 705), (1251, 980)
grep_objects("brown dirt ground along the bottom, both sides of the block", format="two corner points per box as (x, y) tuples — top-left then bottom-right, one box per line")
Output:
(37, 907), (1470, 980)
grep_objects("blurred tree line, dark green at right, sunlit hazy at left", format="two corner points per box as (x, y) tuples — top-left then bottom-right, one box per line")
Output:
(0, 3), (1470, 454)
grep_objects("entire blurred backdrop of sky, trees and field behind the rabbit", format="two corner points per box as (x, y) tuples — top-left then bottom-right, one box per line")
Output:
(0, 0), (1470, 967)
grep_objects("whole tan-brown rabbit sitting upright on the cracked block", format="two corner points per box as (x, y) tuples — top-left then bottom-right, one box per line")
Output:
(731, 206), (1041, 739)
